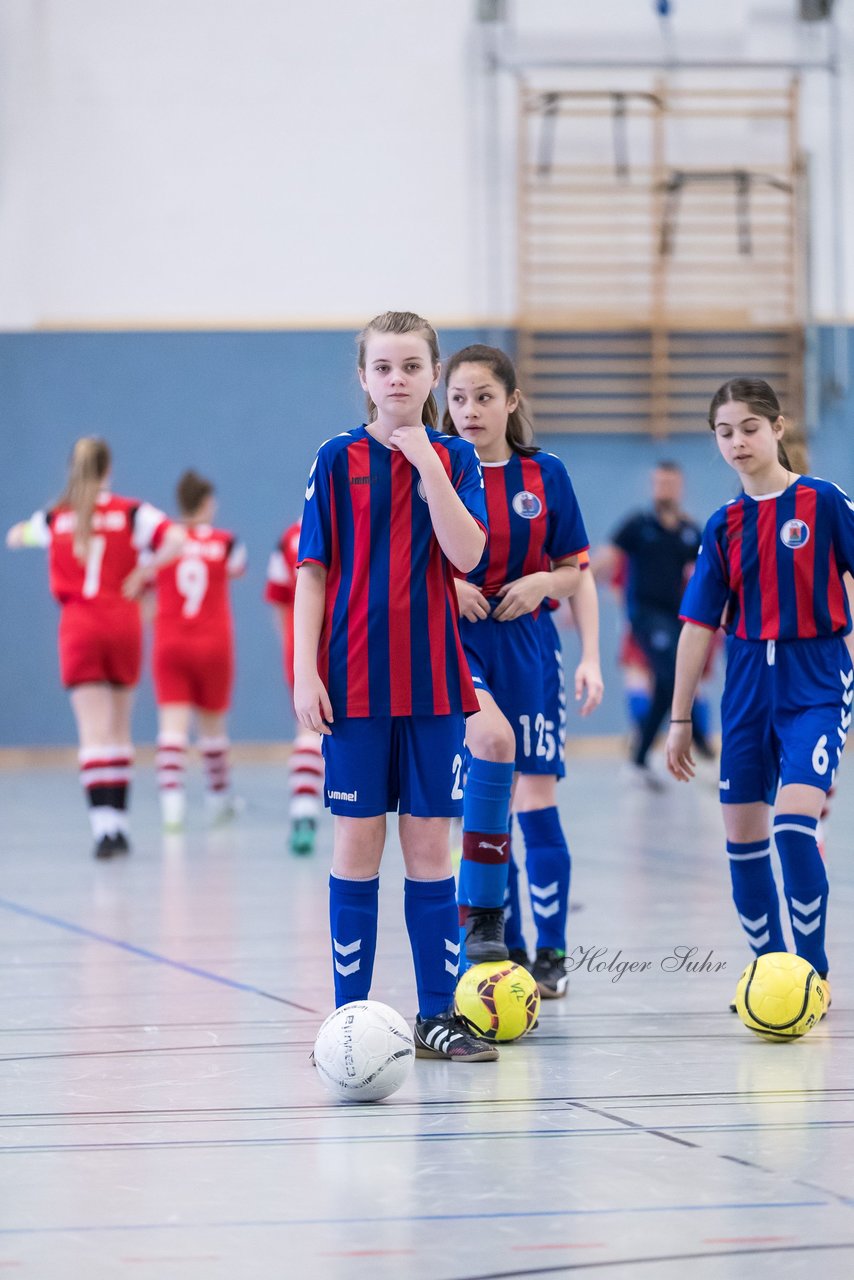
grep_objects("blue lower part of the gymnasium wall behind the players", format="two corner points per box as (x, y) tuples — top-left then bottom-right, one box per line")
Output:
(0, 330), (854, 745)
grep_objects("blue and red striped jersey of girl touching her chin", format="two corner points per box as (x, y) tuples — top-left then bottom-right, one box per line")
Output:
(298, 426), (487, 717)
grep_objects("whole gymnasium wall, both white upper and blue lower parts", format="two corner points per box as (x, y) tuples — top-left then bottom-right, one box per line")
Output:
(0, 0), (854, 745)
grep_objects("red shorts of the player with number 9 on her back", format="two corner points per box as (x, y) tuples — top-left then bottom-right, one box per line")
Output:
(154, 632), (234, 712)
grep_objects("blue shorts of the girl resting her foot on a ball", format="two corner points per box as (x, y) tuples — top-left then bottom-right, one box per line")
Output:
(460, 613), (560, 774)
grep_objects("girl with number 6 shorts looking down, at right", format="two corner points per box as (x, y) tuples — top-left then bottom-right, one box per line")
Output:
(667, 378), (854, 998)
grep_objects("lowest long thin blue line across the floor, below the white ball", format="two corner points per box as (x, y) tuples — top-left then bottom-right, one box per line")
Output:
(0, 1199), (831, 1236)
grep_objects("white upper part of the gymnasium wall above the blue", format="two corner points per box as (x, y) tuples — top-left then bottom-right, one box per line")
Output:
(0, 0), (854, 329)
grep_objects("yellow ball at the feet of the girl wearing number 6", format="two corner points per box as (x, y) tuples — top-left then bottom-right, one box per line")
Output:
(735, 951), (827, 1041)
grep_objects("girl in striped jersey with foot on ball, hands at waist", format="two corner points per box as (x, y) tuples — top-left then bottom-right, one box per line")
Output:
(444, 346), (588, 995)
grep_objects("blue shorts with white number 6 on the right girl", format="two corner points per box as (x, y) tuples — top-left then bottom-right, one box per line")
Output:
(721, 636), (854, 804)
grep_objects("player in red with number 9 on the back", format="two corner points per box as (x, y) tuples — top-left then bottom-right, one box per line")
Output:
(154, 471), (246, 831)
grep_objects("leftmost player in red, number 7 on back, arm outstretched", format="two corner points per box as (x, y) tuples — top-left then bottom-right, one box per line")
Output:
(6, 436), (183, 858)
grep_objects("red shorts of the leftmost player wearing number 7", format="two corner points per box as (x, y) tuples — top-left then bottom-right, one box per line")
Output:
(59, 600), (142, 689)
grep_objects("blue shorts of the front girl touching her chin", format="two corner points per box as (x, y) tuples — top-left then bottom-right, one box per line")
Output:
(323, 714), (466, 818)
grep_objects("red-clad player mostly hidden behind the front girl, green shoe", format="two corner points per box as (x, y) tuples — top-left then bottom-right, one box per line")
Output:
(264, 520), (324, 854)
